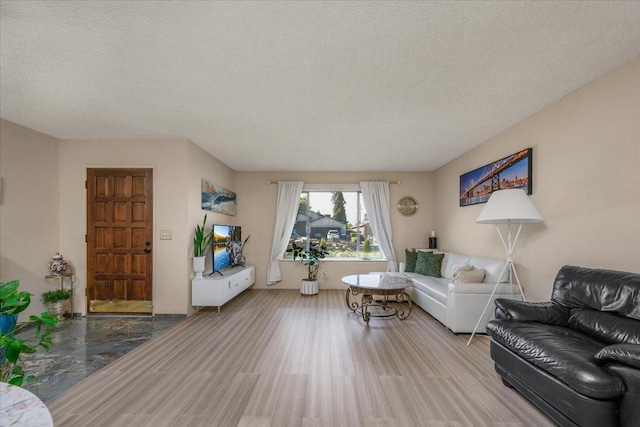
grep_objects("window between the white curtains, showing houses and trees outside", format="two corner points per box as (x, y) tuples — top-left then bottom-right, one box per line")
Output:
(287, 190), (386, 260)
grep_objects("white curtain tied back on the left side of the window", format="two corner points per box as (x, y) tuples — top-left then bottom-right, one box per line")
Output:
(267, 182), (304, 285)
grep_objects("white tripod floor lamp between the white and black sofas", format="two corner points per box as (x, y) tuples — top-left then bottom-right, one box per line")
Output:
(467, 188), (542, 345)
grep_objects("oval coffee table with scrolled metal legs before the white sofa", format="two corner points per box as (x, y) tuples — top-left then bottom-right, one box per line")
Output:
(342, 273), (413, 323)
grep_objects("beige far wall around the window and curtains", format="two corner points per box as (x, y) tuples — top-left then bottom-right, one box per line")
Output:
(236, 172), (435, 289)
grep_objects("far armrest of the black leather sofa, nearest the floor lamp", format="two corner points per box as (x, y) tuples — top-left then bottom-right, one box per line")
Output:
(496, 298), (569, 326)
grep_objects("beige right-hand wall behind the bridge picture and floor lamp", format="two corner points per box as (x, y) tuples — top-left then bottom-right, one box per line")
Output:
(435, 58), (640, 301)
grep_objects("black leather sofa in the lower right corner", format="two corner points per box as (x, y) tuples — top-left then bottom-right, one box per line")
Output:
(487, 266), (640, 427)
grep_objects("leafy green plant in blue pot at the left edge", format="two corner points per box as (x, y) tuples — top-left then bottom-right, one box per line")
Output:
(0, 280), (58, 386)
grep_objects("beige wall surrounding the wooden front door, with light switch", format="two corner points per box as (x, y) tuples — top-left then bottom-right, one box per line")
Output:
(60, 140), (191, 314)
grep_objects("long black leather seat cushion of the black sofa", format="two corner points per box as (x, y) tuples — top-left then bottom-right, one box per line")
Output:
(487, 320), (625, 399)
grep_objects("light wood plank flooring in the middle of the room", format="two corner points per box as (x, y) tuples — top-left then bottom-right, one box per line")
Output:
(49, 289), (553, 427)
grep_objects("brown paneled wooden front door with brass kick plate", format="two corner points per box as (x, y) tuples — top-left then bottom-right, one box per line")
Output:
(87, 169), (153, 313)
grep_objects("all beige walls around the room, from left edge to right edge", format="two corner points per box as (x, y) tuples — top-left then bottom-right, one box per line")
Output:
(0, 54), (640, 314)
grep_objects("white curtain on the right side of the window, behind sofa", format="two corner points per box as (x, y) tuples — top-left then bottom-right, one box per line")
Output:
(360, 182), (397, 272)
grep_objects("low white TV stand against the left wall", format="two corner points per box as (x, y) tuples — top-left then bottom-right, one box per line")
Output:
(191, 265), (256, 316)
